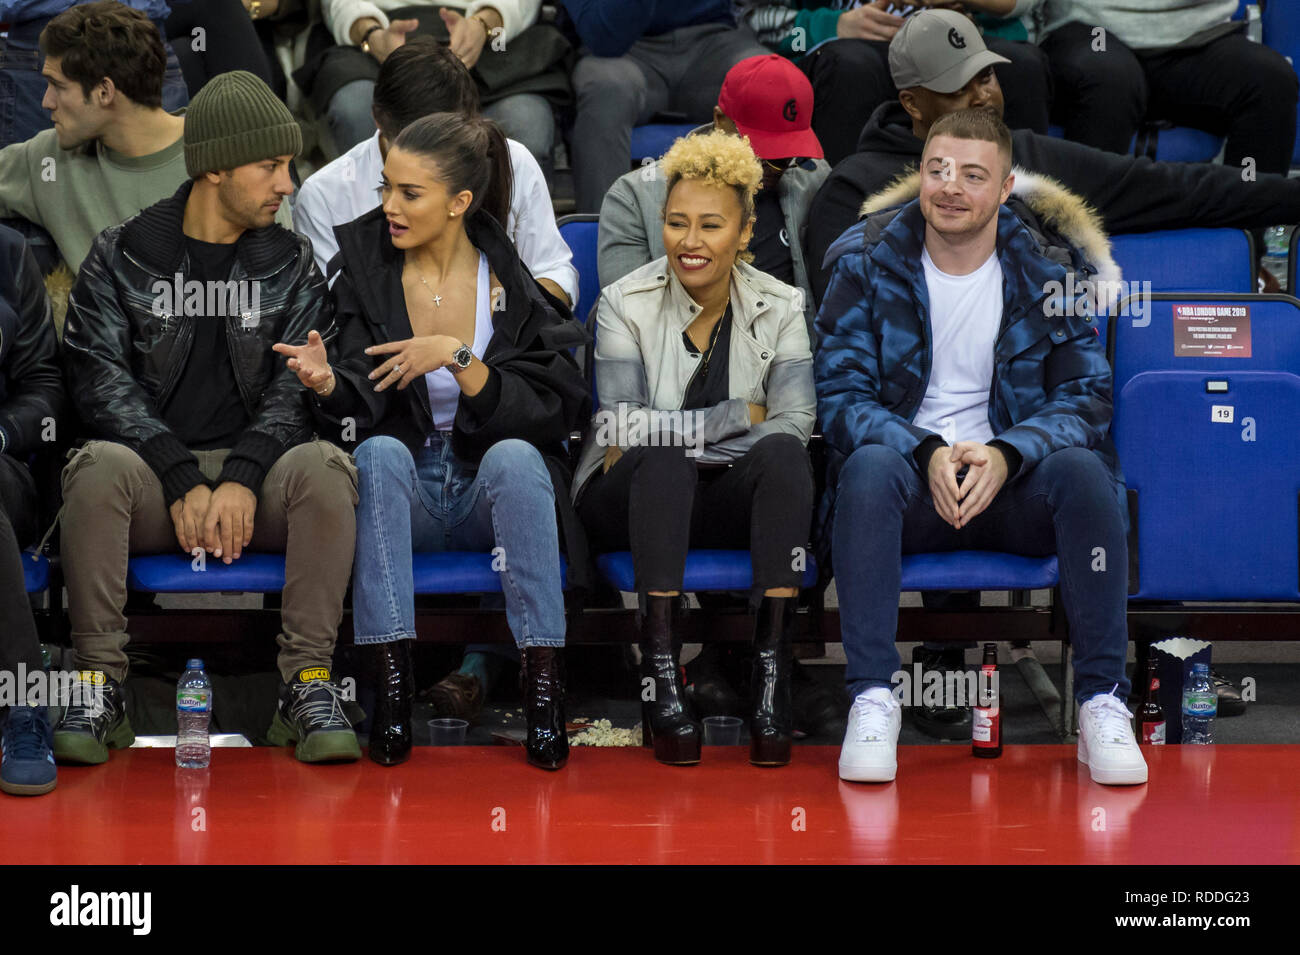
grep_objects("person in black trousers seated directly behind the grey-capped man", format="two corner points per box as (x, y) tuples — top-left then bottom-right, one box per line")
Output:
(774, 0), (1050, 165)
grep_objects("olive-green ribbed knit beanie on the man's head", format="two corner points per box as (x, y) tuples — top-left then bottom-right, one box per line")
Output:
(185, 70), (303, 179)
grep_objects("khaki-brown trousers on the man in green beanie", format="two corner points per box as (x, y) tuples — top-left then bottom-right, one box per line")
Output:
(61, 440), (356, 682)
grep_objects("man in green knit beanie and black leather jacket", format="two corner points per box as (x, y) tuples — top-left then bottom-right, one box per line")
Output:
(55, 71), (360, 763)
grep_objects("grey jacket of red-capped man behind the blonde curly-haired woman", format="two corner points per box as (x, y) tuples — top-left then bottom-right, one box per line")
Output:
(597, 125), (831, 329)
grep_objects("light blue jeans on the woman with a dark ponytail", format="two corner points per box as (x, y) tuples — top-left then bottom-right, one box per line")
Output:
(352, 433), (564, 647)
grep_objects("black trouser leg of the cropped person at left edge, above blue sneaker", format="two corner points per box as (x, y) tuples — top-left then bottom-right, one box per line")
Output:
(0, 453), (42, 673)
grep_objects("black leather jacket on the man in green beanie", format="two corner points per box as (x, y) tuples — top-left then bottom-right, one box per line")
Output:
(64, 182), (334, 504)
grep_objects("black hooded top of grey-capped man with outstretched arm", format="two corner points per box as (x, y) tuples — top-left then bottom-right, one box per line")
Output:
(805, 101), (1300, 304)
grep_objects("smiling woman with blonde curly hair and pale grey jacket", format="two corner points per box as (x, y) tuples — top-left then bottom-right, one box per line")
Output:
(573, 131), (816, 765)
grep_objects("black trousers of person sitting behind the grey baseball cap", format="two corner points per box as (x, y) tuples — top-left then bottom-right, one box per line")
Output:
(800, 36), (1052, 166)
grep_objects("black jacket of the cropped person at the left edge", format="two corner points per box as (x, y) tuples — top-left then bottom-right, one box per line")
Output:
(0, 226), (65, 459)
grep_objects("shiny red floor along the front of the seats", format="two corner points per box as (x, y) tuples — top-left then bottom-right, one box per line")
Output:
(0, 746), (1300, 865)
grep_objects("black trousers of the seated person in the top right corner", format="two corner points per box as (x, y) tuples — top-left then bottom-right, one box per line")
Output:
(1043, 22), (1300, 175)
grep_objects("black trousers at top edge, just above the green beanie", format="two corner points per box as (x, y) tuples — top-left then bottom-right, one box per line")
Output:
(166, 0), (273, 96)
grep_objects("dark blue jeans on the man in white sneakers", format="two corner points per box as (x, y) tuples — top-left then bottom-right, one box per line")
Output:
(831, 444), (1128, 703)
